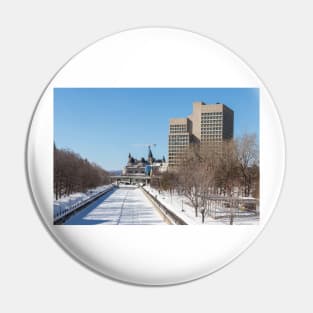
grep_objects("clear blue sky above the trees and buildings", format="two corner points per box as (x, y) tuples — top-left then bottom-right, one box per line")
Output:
(54, 88), (259, 170)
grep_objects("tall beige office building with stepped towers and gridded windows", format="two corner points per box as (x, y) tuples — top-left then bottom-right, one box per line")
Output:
(168, 102), (234, 167)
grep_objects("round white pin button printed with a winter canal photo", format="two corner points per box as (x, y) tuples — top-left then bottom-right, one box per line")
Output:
(26, 28), (285, 285)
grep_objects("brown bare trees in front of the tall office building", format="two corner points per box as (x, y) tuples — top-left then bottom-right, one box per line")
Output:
(151, 135), (259, 218)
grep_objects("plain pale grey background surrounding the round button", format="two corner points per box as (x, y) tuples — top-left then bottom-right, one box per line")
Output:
(0, 1), (313, 312)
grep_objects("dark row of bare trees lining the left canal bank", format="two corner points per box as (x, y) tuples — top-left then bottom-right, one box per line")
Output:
(53, 145), (109, 200)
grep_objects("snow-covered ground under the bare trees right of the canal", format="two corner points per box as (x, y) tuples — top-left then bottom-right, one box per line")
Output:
(144, 186), (259, 225)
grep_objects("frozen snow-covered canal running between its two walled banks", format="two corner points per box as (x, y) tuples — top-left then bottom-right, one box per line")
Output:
(65, 188), (165, 225)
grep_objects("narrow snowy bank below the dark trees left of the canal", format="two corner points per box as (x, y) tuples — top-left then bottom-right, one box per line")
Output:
(53, 185), (113, 220)
